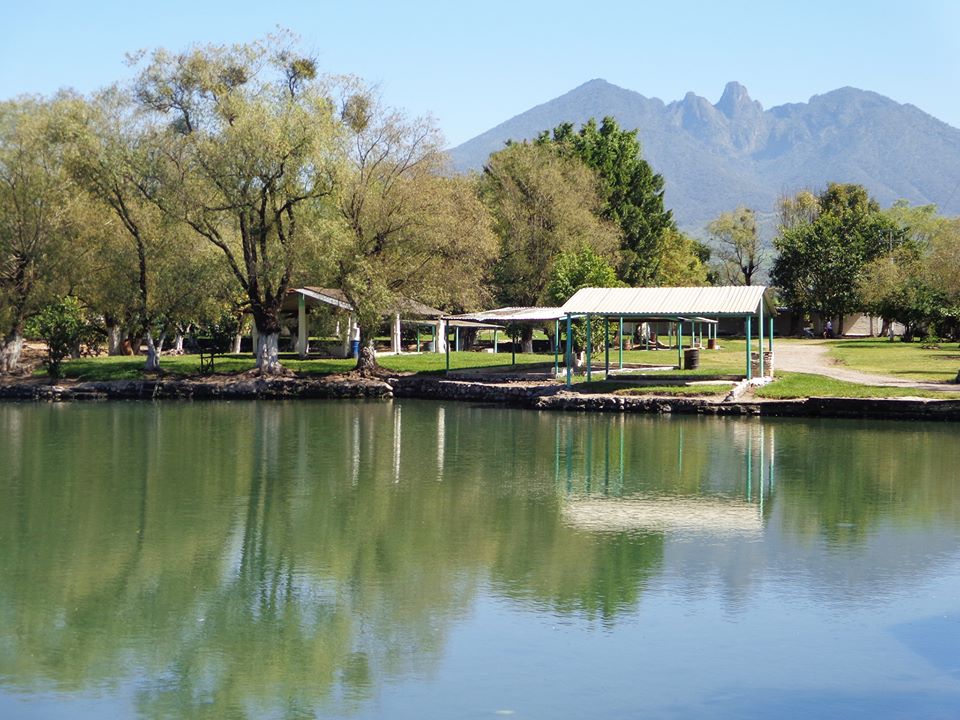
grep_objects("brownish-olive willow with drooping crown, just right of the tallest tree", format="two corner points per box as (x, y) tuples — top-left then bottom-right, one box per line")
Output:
(334, 94), (496, 371)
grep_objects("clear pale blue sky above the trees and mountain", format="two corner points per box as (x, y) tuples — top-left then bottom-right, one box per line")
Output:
(0, 0), (960, 145)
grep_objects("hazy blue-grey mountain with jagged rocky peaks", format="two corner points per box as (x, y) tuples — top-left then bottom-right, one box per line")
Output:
(450, 80), (960, 234)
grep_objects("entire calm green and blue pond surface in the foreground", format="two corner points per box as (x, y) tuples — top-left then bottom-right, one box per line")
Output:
(0, 401), (960, 720)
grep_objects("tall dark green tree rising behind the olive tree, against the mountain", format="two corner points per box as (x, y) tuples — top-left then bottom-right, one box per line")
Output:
(537, 117), (676, 285)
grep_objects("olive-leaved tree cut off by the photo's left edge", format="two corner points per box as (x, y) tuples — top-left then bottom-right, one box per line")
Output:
(0, 98), (76, 374)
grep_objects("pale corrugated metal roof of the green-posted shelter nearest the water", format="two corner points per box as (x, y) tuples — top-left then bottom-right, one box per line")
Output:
(561, 285), (775, 317)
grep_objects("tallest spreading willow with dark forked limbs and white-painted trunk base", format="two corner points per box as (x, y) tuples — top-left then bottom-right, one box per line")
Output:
(135, 36), (340, 373)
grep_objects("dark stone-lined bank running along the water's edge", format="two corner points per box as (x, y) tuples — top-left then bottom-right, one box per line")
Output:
(0, 375), (960, 422)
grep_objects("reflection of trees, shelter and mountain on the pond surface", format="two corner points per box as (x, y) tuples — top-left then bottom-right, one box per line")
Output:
(0, 402), (960, 717)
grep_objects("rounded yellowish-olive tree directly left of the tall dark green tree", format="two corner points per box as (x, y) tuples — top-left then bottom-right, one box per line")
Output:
(481, 143), (618, 352)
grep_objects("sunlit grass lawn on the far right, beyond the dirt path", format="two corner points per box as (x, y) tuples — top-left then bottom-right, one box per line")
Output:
(829, 338), (960, 381)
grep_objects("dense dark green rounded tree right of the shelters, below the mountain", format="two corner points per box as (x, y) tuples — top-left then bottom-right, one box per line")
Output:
(771, 183), (903, 330)
